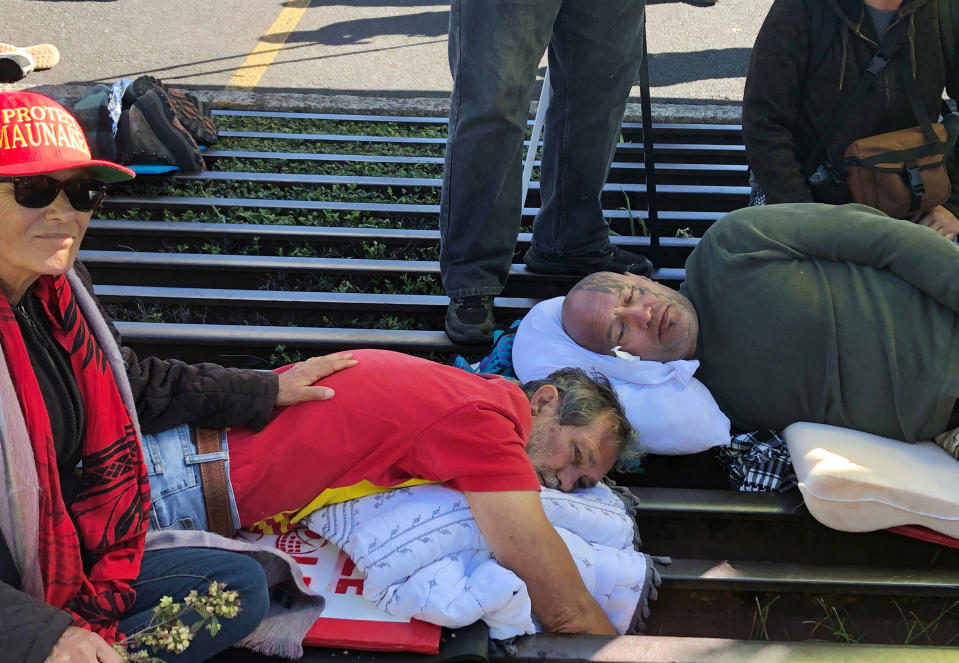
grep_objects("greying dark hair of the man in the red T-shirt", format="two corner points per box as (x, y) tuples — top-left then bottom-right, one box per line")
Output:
(523, 368), (640, 462)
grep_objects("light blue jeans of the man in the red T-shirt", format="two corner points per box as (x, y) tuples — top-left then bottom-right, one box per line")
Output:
(143, 424), (240, 530)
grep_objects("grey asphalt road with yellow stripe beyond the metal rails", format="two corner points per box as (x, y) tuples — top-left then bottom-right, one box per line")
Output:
(0, 0), (772, 121)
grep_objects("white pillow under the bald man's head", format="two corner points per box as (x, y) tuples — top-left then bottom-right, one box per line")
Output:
(513, 297), (729, 454)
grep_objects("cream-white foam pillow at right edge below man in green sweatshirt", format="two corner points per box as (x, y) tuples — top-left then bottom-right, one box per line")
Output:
(783, 422), (959, 538)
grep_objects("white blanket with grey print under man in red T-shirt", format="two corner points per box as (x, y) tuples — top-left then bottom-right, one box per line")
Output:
(303, 484), (659, 639)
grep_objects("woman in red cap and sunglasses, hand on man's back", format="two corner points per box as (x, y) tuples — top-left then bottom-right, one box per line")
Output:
(0, 92), (346, 663)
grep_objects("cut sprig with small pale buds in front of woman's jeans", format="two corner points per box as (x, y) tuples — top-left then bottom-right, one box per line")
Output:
(113, 582), (240, 663)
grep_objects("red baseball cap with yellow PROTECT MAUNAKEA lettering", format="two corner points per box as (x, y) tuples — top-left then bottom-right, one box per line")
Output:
(0, 92), (136, 182)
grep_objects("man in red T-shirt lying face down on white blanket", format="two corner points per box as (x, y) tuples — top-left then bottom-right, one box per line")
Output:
(144, 350), (634, 634)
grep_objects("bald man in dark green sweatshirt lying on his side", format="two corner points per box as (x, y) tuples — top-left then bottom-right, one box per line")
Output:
(562, 203), (959, 442)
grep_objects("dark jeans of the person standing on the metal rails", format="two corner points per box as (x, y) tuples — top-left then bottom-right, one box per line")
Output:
(440, 0), (645, 297)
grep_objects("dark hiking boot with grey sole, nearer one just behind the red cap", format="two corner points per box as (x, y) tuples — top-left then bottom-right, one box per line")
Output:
(117, 90), (204, 173)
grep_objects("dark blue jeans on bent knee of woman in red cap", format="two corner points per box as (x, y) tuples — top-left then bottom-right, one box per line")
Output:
(120, 548), (270, 663)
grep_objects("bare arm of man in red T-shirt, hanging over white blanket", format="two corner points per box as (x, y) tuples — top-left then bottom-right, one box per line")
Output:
(465, 491), (616, 635)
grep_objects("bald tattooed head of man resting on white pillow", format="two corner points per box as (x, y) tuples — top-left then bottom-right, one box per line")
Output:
(563, 272), (699, 361)
